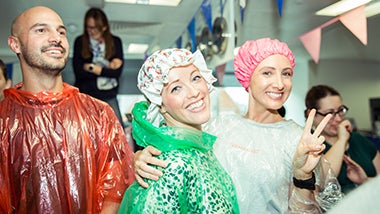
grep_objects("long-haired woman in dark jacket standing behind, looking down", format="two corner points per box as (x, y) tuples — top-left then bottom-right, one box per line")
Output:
(72, 8), (124, 127)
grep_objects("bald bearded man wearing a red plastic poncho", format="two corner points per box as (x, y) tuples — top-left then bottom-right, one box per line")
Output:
(0, 6), (134, 213)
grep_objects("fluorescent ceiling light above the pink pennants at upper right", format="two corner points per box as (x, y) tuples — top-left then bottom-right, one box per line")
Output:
(315, 0), (372, 16)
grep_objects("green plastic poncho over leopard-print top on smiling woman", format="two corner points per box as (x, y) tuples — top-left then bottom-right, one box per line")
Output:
(119, 102), (239, 213)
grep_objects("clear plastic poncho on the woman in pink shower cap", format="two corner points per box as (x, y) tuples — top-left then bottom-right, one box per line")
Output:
(204, 114), (340, 213)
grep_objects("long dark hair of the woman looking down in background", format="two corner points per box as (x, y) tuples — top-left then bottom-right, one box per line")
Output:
(82, 8), (115, 59)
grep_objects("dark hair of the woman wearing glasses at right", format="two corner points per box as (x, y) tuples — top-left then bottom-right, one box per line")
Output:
(305, 85), (340, 118)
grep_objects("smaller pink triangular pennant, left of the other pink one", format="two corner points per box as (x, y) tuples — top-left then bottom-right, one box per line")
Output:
(299, 28), (321, 63)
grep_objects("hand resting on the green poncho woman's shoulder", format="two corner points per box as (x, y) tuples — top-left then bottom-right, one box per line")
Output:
(133, 146), (167, 188)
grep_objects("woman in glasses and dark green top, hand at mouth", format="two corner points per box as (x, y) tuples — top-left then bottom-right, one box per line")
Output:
(305, 85), (380, 194)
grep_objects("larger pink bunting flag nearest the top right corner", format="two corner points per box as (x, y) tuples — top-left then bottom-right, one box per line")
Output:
(339, 5), (367, 45)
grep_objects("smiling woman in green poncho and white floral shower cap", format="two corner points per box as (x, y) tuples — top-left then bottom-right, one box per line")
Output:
(119, 48), (239, 213)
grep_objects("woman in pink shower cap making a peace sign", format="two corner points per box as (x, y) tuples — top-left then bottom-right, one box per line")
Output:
(134, 38), (338, 213)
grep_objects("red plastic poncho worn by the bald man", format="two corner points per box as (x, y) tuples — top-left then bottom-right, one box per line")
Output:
(0, 84), (134, 213)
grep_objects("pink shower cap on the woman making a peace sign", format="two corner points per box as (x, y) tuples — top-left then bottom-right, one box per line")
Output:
(234, 38), (295, 91)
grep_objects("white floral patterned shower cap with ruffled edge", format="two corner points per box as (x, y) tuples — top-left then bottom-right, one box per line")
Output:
(137, 48), (216, 127)
